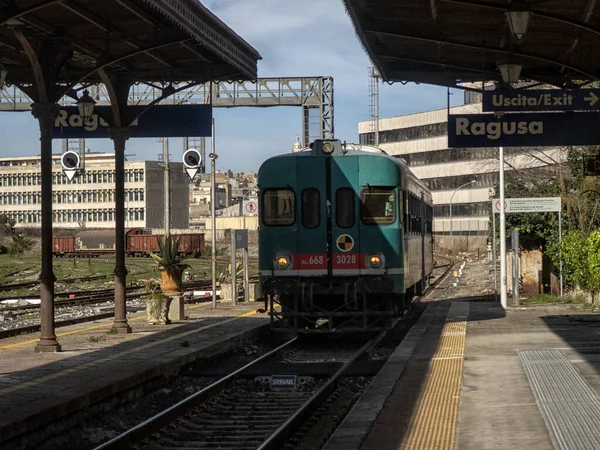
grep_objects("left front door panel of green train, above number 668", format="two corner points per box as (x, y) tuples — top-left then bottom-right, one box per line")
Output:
(294, 156), (330, 277)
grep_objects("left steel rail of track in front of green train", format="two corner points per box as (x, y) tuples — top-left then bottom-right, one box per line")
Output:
(94, 337), (298, 450)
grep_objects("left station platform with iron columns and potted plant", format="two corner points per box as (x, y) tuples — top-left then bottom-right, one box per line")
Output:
(0, 301), (269, 449)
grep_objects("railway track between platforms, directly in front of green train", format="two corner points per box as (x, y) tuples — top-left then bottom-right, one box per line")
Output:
(96, 332), (385, 450)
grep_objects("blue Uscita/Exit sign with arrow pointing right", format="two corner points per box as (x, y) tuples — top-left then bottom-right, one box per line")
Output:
(482, 89), (600, 112)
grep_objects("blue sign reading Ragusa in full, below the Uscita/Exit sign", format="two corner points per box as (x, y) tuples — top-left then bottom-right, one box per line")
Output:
(448, 112), (600, 147)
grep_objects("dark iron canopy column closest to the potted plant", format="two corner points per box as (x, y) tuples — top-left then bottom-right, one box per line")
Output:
(108, 127), (131, 334)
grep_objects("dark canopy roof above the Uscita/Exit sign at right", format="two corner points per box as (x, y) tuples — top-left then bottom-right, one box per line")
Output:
(343, 0), (600, 87)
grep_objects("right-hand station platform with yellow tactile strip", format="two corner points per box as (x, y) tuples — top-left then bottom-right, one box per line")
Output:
(324, 298), (600, 450)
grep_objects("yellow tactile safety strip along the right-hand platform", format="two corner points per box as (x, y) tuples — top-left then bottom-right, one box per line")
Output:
(402, 303), (468, 450)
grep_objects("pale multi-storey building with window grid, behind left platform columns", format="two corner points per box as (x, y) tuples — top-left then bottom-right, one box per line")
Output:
(0, 153), (189, 228)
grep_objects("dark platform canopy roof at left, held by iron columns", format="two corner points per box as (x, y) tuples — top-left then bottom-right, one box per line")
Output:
(0, 0), (261, 99)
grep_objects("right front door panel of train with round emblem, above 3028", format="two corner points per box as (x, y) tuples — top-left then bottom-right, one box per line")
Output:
(330, 156), (361, 276)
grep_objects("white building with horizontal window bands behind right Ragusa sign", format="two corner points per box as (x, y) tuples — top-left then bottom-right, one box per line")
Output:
(358, 96), (564, 236)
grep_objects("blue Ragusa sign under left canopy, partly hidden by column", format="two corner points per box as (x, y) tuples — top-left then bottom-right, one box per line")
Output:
(52, 105), (212, 139)
